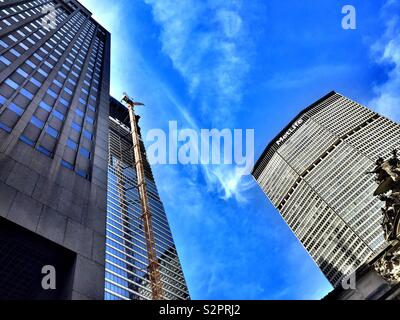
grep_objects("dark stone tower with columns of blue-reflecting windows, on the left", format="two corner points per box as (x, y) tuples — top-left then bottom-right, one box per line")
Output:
(0, 0), (110, 299)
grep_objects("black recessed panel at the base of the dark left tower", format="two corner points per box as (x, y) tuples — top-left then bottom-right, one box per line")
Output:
(0, 218), (76, 300)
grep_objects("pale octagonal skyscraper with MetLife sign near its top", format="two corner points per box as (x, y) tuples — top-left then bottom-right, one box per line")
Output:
(253, 92), (400, 286)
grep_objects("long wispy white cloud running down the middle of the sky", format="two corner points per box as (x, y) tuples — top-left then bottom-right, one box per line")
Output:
(144, 0), (255, 201)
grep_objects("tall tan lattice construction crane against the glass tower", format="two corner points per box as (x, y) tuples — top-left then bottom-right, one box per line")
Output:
(122, 93), (164, 300)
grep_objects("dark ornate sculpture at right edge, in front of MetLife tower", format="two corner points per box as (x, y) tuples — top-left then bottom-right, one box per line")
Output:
(368, 150), (400, 241)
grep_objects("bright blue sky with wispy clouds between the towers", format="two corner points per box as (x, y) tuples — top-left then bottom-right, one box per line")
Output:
(81, 0), (400, 299)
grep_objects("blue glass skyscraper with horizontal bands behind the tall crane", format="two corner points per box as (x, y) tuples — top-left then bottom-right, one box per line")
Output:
(105, 98), (189, 300)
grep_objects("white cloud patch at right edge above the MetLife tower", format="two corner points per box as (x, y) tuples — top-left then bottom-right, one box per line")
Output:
(369, 0), (400, 121)
